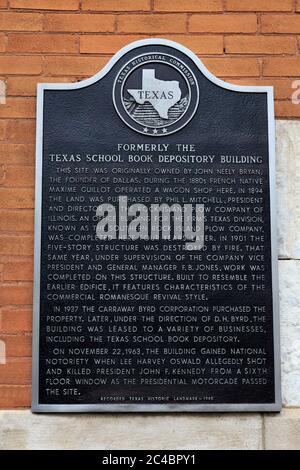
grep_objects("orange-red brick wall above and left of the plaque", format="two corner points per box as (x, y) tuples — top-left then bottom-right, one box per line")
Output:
(0, 0), (300, 408)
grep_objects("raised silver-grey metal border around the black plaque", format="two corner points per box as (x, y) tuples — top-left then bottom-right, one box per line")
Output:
(31, 38), (282, 413)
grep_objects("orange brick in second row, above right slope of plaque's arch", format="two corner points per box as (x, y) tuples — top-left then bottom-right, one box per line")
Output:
(189, 14), (257, 33)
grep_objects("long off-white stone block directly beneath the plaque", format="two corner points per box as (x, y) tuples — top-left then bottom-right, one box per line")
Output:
(0, 411), (263, 450)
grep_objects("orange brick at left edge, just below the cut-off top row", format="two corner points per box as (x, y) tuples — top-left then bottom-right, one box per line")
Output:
(0, 12), (43, 31)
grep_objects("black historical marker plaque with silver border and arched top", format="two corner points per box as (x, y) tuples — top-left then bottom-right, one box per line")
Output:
(32, 39), (281, 412)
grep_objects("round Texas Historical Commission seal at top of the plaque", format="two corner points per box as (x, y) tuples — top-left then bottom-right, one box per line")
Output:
(113, 52), (199, 137)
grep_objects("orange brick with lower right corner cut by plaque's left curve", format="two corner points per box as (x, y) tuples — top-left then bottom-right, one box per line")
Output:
(45, 56), (108, 76)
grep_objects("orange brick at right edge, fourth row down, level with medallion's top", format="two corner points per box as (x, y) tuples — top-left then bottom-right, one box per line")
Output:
(263, 57), (300, 77)
